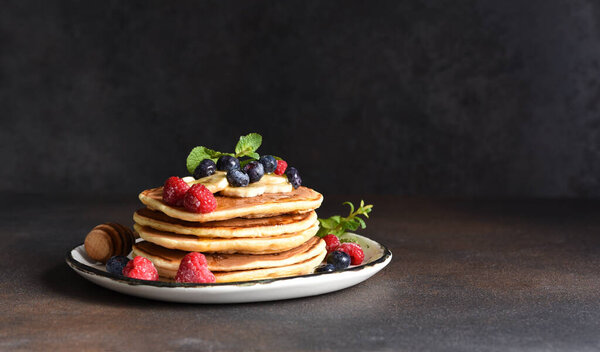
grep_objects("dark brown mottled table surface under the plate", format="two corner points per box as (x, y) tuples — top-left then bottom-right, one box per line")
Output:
(0, 194), (600, 351)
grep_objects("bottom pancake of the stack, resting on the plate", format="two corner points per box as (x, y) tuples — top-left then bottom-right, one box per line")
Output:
(135, 243), (327, 282)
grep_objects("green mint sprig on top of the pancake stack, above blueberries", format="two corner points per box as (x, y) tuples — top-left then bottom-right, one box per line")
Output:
(186, 133), (262, 174)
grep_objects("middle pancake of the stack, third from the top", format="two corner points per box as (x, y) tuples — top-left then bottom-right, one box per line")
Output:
(133, 221), (319, 254)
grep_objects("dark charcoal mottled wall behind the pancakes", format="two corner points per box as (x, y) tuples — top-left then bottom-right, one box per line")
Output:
(0, 0), (600, 197)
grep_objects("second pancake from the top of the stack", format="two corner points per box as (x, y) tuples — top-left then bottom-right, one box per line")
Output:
(133, 208), (317, 238)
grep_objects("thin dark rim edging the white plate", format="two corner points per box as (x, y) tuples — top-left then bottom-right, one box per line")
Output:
(65, 233), (392, 288)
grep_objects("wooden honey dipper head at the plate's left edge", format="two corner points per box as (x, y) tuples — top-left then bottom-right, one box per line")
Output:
(84, 222), (136, 263)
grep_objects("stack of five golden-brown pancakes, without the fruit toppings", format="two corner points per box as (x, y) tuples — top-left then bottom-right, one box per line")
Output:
(133, 183), (327, 282)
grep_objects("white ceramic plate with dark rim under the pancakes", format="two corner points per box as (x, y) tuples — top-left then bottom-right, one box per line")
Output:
(66, 233), (392, 303)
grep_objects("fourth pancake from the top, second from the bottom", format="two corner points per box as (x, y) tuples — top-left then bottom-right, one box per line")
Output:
(132, 237), (325, 272)
